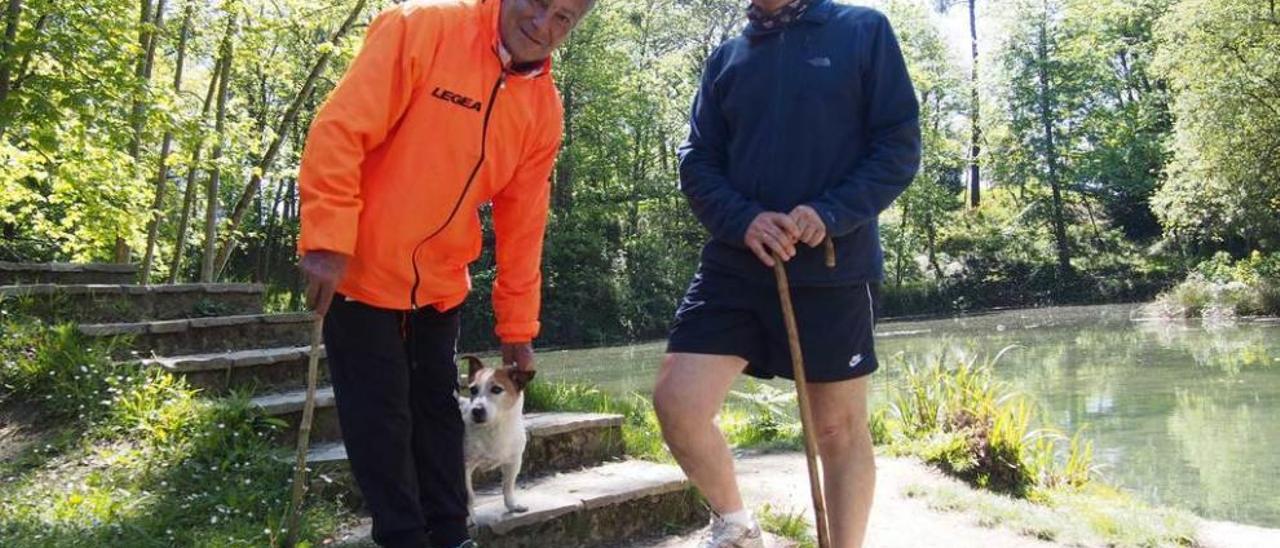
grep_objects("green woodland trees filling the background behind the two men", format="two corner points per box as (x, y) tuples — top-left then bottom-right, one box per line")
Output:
(0, 0), (1280, 347)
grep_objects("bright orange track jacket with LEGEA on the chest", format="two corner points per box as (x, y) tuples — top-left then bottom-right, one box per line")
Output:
(298, 0), (563, 343)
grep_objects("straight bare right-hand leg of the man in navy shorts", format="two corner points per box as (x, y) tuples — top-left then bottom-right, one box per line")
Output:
(809, 376), (876, 548)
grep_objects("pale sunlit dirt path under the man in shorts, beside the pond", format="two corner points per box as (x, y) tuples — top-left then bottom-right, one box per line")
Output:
(636, 453), (1280, 548)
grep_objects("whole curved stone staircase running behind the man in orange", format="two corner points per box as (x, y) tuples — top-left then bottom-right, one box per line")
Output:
(0, 262), (707, 547)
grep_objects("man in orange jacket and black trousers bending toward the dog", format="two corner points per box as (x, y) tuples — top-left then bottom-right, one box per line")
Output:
(298, 0), (594, 547)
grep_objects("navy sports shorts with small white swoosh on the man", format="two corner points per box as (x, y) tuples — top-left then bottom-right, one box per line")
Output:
(667, 269), (879, 383)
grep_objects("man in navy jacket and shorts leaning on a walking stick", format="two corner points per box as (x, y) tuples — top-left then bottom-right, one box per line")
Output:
(654, 0), (920, 547)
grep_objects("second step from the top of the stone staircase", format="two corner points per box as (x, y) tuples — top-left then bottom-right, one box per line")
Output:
(0, 283), (264, 323)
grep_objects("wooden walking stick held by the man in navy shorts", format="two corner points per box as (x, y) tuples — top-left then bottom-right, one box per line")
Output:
(773, 237), (836, 548)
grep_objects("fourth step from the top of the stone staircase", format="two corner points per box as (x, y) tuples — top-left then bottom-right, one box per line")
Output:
(142, 346), (329, 394)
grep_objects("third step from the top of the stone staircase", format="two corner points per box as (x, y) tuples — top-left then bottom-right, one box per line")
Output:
(79, 312), (312, 359)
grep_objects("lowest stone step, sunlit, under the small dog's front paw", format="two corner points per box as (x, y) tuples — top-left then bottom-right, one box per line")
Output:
(322, 461), (708, 548)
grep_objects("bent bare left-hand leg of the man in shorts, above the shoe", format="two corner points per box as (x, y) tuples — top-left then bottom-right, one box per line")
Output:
(653, 353), (746, 515)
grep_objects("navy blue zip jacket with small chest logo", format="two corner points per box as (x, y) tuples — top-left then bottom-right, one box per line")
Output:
(680, 0), (920, 286)
